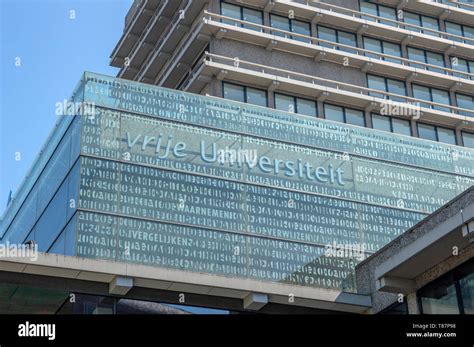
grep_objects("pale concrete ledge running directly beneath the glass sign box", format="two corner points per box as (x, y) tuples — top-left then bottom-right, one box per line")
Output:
(0, 253), (371, 313)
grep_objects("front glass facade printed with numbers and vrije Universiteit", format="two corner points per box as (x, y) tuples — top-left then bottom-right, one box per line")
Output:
(72, 73), (474, 291)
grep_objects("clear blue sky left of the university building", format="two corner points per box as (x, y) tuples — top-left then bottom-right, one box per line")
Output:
(0, 0), (133, 214)
